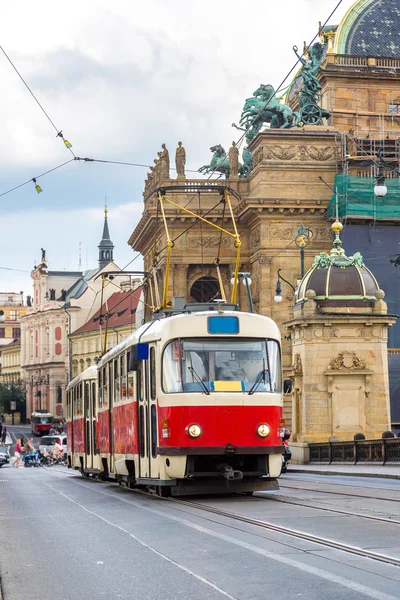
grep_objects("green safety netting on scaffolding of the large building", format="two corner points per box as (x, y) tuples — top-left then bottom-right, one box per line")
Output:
(326, 173), (400, 220)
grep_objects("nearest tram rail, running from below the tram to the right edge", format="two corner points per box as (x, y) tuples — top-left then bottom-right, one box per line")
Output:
(167, 498), (400, 567)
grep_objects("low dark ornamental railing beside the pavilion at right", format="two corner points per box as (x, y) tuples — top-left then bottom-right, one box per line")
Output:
(310, 438), (400, 465)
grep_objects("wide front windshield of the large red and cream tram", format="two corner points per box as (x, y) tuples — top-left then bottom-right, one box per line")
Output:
(163, 338), (282, 394)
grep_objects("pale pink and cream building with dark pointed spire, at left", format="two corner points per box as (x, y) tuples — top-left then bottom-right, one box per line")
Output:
(21, 211), (120, 418)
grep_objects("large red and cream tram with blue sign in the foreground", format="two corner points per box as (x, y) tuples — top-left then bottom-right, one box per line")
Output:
(67, 305), (283, 495)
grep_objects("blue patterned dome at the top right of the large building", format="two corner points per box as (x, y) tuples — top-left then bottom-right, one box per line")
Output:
(335, 0), (400, 58)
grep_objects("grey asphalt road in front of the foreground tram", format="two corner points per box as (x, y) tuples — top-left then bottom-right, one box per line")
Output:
(0, 466), (400, 600)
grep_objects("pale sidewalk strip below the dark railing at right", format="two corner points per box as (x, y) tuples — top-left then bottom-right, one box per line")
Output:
(288, 463), (400, 479)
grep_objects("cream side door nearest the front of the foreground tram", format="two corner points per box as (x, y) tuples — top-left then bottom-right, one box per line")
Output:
(136, 346), (160, 478)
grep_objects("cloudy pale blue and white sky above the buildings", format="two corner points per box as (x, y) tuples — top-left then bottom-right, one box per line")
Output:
(0, 0), (353, 294)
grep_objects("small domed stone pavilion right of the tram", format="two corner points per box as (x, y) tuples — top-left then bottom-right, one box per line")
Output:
(286, 221), (397, 442)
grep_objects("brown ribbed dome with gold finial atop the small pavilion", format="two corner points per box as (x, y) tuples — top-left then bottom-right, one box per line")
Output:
(296, 221), (379, 307)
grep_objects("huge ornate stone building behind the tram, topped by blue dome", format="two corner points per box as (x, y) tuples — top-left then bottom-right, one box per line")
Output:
(129, 0), (400, 427)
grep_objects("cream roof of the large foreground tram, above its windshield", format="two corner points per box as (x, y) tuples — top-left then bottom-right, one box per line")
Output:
(97, 310), (281, 368)
